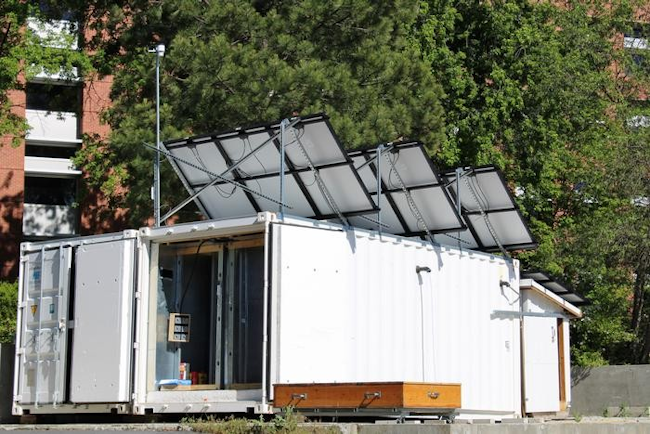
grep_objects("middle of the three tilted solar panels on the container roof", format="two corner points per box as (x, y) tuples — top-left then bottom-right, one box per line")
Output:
(348, 142), (464, 239)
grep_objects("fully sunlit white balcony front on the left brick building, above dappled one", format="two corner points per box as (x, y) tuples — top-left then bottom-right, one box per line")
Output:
(25, 109), (81, 143)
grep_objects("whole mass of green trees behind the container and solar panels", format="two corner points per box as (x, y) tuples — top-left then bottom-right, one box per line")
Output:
(68, 0), (650, 365)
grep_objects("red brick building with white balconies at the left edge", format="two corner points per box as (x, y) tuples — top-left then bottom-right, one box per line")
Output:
(0, 15), (121, 280)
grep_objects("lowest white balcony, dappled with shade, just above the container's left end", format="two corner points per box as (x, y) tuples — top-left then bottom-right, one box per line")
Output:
(23, 203), (78, 237)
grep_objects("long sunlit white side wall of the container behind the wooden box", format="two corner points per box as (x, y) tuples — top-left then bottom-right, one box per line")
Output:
(271, 225), (521, 414)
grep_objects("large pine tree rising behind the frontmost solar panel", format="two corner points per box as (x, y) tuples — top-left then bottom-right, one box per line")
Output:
(72, 0), (444, 224)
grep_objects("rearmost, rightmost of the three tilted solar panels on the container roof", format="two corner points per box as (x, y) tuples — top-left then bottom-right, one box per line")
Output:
(436, 166), (537, 252)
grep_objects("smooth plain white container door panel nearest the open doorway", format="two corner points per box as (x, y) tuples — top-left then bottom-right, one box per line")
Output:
(70, 239), (135, 403)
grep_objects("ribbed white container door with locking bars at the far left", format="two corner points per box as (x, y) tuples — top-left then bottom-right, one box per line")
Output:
(18, 246), (72, 405)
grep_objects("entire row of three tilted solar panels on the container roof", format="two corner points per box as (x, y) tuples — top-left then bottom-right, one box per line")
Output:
(163, 114), (534, 251)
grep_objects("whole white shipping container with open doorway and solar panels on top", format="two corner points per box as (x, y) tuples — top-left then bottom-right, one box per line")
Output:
(13, 212), (568, 418)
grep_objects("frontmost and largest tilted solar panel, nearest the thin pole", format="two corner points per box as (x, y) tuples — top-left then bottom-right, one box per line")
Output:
(163, 115), (376, 223)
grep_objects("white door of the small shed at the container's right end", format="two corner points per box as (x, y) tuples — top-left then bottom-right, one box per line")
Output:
(523, 316), (560, 413)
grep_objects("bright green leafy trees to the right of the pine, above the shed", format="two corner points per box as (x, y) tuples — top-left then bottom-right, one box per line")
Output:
(412, 0), (650, 365)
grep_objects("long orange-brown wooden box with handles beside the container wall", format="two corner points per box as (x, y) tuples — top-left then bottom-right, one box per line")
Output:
(273, 382), (460, 409)
